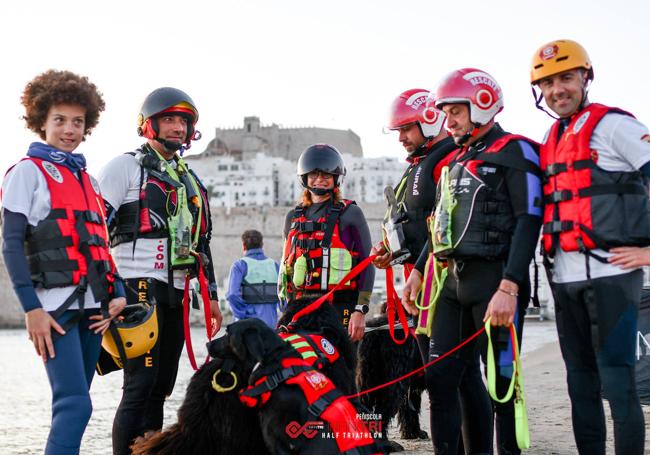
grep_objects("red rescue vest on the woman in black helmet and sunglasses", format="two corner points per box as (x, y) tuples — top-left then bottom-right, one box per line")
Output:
(279, 199), (359, 301)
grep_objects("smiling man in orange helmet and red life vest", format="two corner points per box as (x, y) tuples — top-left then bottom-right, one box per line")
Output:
(530, 40), (650, 455)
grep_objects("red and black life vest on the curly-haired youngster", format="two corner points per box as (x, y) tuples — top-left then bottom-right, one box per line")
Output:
(25, 158), (114, 301)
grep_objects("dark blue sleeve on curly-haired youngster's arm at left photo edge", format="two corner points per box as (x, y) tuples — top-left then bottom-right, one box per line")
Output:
(2, 209), (43, 313)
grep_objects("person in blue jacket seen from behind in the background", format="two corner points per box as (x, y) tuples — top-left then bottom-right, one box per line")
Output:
(226, 230), (280, 328)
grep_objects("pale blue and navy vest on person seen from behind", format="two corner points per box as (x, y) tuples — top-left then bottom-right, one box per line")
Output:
(241, 257), (278, 304)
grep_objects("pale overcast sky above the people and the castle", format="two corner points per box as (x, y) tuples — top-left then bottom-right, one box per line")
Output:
(0, 0), (650, 173)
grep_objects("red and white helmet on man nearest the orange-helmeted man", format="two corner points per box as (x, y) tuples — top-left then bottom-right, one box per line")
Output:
(435, 68), (503, 125)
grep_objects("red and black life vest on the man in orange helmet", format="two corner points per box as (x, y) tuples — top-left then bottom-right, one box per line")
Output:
(541, 104), (650, 255)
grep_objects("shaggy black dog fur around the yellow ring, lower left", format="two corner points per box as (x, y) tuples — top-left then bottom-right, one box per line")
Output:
(132, 358), (269, 455)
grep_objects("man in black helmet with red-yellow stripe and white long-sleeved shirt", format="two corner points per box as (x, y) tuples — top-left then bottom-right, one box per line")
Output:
(99, 87), (221, 454)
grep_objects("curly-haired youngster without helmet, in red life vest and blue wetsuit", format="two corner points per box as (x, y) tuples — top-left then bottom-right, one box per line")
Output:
(2, 70), (126, 454)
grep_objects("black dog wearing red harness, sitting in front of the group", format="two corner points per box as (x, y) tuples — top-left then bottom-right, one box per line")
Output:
(210, 319), (381, 455)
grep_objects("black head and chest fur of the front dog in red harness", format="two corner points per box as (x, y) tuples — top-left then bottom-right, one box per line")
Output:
(210, 319), (379, 455)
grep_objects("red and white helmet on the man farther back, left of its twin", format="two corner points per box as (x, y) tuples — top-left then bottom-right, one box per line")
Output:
(386, 88), (445, 138)
